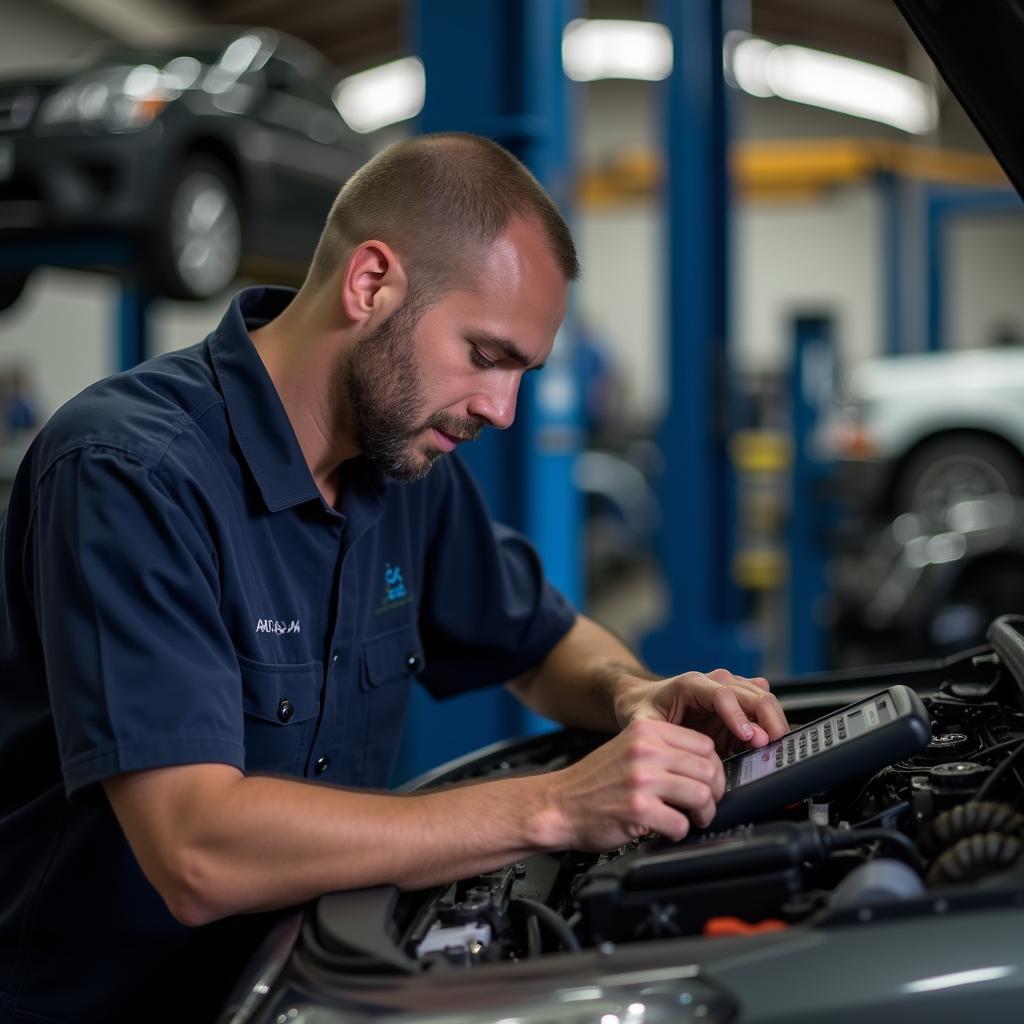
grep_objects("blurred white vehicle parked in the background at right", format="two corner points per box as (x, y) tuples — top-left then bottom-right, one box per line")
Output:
(818, 348), (1024, 518)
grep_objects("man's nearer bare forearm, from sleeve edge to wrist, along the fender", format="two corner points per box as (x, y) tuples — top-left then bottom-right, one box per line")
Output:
(108, 765), (568, 925)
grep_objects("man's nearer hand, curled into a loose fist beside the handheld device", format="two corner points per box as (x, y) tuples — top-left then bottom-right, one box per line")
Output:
(539, 721), (725, 852)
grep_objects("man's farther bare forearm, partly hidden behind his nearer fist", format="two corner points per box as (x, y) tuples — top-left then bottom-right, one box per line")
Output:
(507, 615), (657, 732)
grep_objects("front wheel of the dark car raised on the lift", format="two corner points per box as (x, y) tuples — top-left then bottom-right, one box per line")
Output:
(150, 155), (243, 299)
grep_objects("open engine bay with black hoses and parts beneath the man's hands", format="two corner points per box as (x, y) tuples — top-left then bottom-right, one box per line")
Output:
(297, 616), (1024, 979)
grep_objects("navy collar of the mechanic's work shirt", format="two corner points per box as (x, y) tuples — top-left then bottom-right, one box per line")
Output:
(208, 287), (384, 512)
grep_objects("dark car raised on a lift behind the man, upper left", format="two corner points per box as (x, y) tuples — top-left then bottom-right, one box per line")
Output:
(0, 28), (370, 308)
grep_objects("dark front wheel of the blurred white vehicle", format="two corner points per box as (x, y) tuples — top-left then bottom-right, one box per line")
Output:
(893, 434), (1024, 520)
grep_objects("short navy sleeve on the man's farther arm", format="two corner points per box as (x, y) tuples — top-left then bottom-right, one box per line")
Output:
(420, 458), (577, 697)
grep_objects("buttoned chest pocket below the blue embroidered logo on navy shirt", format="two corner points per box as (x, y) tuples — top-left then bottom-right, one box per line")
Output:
(359, 626), (426, 786)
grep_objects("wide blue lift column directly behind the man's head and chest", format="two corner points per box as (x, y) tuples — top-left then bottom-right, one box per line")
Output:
(393, 0), (583, 781)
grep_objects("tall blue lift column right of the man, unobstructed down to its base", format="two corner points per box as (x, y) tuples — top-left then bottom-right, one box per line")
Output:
(644, 0), (758, 674)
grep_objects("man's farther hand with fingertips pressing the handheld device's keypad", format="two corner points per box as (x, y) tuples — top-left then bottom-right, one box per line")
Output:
(615, 669), (790, 756)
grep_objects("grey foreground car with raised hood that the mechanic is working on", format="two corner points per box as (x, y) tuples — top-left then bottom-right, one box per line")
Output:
(209, 0), (1024, 1024)
